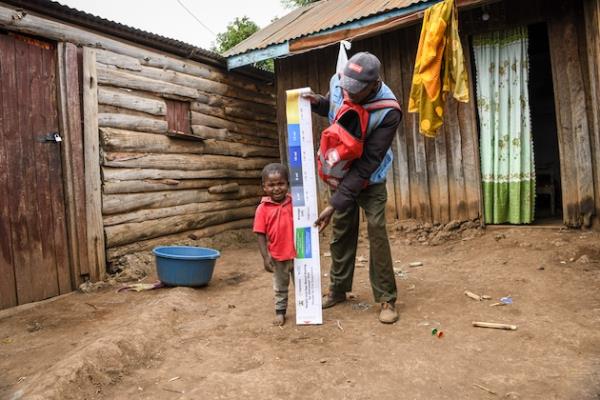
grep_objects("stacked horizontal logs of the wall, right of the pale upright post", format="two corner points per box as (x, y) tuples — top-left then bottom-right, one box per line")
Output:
(95, 50), (279, 261)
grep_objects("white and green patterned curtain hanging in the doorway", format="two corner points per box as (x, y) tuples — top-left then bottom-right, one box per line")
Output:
(473, 28), (535, 224)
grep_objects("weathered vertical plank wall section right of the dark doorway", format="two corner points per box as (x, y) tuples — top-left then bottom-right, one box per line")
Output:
(548, 2), (598, 227)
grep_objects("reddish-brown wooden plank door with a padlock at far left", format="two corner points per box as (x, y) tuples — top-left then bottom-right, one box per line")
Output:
(0, 32), (71, 308)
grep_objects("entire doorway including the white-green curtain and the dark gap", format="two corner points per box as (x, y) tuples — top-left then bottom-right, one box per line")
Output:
(472, 23), (562, 224)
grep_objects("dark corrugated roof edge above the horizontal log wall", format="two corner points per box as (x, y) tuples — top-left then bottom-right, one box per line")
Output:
(0, 0), (272, 79)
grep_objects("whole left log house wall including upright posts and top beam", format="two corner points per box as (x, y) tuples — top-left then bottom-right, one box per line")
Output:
(0, 3), (279, 283)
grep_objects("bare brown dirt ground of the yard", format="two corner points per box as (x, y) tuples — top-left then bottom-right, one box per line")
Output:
(0, 222), (600, 400)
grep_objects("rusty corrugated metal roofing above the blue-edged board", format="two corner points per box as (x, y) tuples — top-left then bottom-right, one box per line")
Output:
(223, 0), (430, 57)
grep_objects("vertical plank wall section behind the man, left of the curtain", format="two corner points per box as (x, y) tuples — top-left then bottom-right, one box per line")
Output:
(276, 25), (481, 223)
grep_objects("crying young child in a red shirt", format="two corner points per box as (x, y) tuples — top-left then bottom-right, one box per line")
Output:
(253, 163), (296, 326)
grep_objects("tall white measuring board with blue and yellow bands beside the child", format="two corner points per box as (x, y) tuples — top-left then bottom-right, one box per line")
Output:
(286, 88), (323, 325)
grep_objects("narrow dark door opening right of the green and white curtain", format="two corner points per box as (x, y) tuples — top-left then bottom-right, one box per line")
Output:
(528, 23), (562, 223)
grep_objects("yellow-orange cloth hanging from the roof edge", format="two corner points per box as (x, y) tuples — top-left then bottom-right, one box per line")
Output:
(408, 0), (469, 137)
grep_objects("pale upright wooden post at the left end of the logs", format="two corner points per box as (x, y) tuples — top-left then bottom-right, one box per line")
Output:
(83, 47), (106, 280)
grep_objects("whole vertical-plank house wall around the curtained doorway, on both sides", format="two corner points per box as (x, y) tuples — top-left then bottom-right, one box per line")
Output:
(276, 0), (600, 227)
